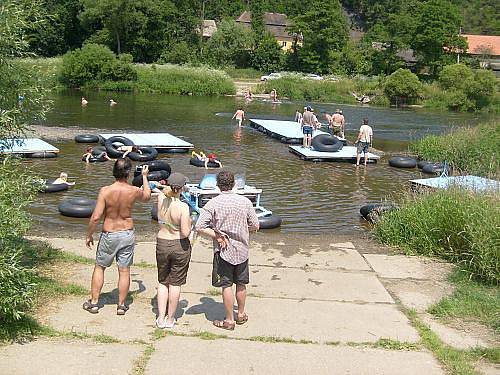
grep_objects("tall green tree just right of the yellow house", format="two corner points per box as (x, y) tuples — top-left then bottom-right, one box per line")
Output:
(290, 0), (348, 73)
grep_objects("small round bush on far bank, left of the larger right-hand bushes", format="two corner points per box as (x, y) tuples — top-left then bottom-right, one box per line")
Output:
(384, 69), (423, 104)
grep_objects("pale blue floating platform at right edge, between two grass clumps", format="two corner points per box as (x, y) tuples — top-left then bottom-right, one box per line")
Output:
(410, 176), (500, 192)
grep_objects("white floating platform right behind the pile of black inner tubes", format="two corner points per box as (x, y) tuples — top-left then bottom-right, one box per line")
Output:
(99, 133), (194, 152)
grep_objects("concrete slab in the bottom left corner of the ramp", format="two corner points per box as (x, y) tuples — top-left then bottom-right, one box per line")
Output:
(0, 339), (144, 375)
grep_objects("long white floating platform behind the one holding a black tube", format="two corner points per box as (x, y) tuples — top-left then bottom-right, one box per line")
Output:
(249, 119), (336, 144)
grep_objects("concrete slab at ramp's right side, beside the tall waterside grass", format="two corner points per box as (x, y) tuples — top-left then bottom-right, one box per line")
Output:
(364, 254), (452, 280)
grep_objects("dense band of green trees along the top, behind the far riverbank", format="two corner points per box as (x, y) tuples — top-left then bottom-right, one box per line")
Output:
(29, 0), (500, 75)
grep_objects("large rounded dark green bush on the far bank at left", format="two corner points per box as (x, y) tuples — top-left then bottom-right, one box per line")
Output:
(61, 44), (137, 87)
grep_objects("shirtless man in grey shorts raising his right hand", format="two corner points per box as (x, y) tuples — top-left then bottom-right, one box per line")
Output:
(83, 159), (151, 315)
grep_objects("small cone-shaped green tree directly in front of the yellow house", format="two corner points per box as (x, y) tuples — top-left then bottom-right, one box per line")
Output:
(250, 33), (285, 72)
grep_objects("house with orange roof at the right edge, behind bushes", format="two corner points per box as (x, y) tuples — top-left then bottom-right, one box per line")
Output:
(462, 34), (500, 77)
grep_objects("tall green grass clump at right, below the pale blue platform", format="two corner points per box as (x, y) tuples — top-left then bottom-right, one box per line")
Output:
(374, 188), (500, 284)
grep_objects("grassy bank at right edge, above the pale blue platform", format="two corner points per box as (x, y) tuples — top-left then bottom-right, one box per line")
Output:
(410, 122), (500, 178)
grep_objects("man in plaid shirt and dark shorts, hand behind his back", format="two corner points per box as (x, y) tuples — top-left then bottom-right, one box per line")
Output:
(196, 171), (259, 330)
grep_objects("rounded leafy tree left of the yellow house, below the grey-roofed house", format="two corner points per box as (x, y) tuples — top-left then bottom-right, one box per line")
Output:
(206, 20), (253, 66)
